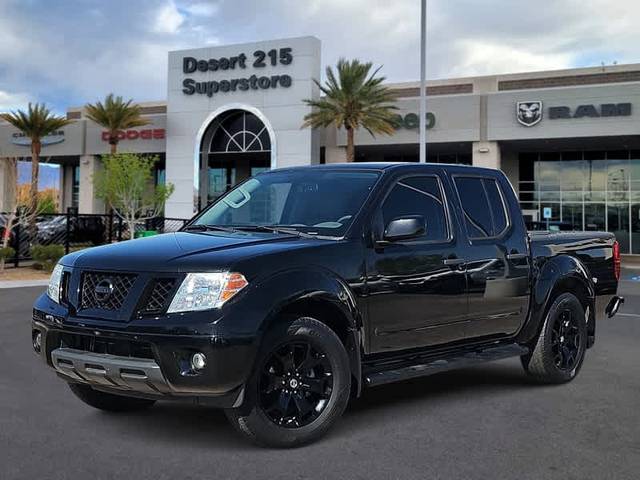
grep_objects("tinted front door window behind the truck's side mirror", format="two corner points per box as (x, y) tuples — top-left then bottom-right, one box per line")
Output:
(382, 177), (448, 241)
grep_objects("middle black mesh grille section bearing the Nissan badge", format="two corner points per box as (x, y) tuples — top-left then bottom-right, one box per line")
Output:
(80, 272), (137, 310)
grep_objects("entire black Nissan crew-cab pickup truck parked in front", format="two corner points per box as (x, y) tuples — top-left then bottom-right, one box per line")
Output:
(32, 163), (623, 447)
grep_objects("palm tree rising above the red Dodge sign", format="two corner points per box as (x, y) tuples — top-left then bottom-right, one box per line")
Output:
(86, 93), (151, 155)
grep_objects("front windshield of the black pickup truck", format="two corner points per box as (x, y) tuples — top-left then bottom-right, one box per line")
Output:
(190, 169), (379, 237)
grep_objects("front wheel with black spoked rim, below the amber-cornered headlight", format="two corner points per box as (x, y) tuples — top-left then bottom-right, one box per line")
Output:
(225, 317), (351, 448)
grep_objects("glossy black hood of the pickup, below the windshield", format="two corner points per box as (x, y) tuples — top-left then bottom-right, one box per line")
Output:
(62, 232), (317, 272)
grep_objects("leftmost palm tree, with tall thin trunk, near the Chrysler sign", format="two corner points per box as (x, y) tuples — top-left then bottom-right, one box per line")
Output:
(0, 103), (72, 224)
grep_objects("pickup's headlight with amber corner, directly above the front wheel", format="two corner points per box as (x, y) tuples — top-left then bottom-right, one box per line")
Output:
(167, 272), (248, 313)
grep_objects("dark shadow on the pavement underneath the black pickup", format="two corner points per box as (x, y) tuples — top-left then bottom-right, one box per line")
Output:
(89, 362), (536, 450)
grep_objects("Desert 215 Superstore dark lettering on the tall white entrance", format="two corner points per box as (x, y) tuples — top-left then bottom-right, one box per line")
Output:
(182, 47), (293, 97)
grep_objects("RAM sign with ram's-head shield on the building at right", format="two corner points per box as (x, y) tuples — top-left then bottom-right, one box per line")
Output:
(516, 100), (631, 127)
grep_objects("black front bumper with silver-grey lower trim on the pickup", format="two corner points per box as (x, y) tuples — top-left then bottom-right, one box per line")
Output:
(32, 310), (256, 408)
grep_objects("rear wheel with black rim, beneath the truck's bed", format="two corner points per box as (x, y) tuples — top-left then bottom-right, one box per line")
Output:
(521, 293), (587, 384)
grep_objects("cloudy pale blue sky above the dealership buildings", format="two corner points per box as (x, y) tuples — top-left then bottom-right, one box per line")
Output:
(0, 0), (640, 112)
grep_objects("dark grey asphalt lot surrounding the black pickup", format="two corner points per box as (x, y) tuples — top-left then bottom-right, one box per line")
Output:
(0, 269), (640, 480)
